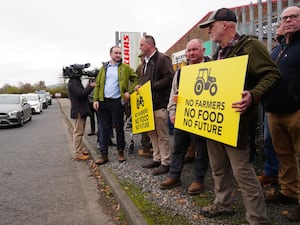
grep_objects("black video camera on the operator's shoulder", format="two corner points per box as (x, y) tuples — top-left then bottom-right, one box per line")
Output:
(63, 63), (99, 79)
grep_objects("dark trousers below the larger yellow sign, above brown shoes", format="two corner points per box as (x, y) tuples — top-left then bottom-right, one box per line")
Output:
(169, 128), (208, 183)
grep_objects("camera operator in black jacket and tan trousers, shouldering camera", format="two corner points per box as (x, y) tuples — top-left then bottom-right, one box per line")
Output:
(64, 64), (96, 160)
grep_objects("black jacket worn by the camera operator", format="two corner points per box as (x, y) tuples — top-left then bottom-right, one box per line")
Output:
(68, 78), (93, 119)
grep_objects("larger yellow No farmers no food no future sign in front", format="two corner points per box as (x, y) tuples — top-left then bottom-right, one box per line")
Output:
(175, 55), (248, 147)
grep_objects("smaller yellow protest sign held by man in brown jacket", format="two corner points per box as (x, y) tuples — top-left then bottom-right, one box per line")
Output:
(130, 81), (155, 134)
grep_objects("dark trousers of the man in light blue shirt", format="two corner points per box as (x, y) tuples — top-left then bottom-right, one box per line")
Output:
(98, 98), (125, 155)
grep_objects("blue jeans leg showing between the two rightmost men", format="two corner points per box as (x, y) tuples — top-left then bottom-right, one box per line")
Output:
(263, 113), (279, 177)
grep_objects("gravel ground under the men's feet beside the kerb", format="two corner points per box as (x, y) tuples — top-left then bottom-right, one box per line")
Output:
(86, 127), (297, 225)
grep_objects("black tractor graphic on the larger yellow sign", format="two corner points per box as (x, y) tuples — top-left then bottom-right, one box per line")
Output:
(194, 68), (218, 96)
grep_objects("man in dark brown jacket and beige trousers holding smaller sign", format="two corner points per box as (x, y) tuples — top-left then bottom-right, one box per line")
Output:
(136, 35), (174, 175)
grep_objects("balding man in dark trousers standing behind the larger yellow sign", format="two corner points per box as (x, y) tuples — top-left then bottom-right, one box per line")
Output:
(160, 39), (209, 195)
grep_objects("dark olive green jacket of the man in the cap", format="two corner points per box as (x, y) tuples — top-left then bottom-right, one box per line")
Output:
(213, 35), (281, 148)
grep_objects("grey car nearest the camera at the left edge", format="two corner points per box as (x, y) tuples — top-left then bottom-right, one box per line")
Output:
(0, 94), (32, 127)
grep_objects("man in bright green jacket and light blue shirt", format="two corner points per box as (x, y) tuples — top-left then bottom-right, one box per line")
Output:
(94, 46), (139, 165)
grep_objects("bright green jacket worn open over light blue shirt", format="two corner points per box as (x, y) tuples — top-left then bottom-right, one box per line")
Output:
(94, 62), (139, 101)
